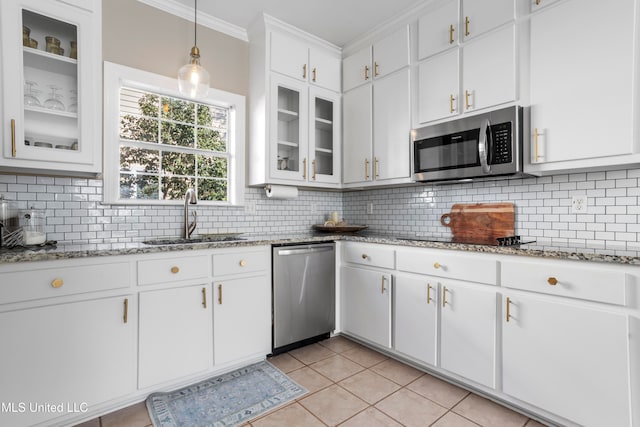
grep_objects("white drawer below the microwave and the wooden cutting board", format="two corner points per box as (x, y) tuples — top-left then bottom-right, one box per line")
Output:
(398, 248), (498, 285)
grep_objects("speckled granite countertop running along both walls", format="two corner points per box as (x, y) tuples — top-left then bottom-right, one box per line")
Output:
(0, 232), (640, 265)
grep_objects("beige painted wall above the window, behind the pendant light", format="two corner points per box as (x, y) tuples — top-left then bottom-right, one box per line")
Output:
(102, 0), (249, 96)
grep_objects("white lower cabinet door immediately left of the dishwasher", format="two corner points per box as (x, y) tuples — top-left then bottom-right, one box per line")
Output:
(213, 275), (271, 365)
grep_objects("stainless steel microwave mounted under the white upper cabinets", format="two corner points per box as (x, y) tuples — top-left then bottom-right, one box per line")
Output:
(411, 106), (528, 182)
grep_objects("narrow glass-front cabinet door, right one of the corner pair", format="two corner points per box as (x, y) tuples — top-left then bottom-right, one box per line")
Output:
(309, 88), (340, 184)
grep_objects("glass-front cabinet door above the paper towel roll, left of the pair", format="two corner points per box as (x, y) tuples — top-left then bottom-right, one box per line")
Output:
(269, 75), (309, 181)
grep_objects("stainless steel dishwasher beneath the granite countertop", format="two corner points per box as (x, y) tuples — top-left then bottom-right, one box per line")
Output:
(273, 243), (335, 354)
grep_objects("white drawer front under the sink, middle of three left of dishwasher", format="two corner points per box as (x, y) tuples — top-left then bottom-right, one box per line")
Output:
(138, 255), (209, 285)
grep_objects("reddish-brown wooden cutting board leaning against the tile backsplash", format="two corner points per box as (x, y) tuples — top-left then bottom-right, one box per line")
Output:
(440, 203), (516, 245)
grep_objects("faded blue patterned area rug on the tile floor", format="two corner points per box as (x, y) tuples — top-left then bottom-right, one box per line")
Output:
(146, 361), (307, 427)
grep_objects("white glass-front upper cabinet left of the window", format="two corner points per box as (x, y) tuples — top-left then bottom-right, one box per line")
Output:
(0, 0), (102, 174)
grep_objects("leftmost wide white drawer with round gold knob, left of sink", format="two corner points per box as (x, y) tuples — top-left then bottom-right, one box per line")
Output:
(0, 261), (131, 304)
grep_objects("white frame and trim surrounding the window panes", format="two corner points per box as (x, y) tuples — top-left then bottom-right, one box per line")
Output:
(103, 61), (246, 206)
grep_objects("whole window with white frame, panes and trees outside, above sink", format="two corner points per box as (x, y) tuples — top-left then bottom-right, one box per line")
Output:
(104, 62), (245, 204)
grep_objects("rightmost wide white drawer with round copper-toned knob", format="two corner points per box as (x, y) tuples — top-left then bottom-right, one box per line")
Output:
(501, 260), (627, 305)
